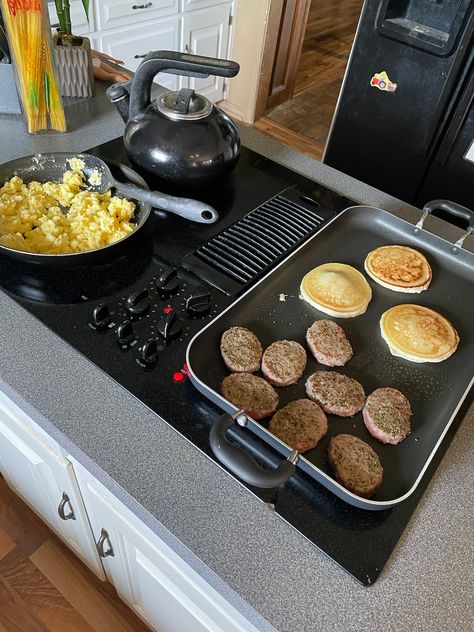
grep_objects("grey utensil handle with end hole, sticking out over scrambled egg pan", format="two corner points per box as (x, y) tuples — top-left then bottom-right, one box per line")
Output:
(117, 182), (219, 224)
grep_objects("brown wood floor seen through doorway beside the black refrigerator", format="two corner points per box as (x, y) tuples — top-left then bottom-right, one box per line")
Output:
(254, 0), (363, 160)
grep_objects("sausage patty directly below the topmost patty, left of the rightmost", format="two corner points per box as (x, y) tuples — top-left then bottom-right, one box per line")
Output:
(306, 371), (365, 417)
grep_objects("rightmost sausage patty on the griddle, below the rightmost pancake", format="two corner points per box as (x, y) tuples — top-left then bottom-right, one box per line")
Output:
(362, 387), (411, 445)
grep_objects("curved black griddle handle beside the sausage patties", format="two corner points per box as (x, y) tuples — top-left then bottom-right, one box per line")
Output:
(209, 411), (298, 489)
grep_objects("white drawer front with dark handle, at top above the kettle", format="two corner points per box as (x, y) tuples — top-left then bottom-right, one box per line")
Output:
(97, 0), (178, 31)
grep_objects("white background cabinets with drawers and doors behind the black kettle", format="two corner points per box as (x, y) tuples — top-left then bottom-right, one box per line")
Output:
(48, 0), (233, 102)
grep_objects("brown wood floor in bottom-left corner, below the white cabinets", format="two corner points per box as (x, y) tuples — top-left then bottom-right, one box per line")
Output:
(0, 477), (150, 632)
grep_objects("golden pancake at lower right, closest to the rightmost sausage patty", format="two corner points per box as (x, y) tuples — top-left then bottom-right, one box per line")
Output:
(380, 304), (459, 362)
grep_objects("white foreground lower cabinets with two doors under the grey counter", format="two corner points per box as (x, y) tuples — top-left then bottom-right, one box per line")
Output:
(0, 392), (256, 632)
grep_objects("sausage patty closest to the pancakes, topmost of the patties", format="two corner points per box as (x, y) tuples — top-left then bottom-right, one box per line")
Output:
(306, 320), (352, 366)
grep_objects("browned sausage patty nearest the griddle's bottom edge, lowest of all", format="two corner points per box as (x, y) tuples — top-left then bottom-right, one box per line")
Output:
(328, 434), (383, 498)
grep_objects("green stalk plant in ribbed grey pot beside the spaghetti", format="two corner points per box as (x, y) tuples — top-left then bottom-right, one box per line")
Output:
(53, 0), (94, 97)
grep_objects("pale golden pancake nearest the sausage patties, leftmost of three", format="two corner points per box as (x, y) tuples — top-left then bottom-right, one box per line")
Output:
(300, 263), (372, 318)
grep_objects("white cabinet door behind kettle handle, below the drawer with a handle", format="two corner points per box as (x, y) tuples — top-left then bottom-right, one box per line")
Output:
(98, 17), (179, 90)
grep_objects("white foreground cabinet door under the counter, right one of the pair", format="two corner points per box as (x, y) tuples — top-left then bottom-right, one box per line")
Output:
(74, 463), (256, 632)
